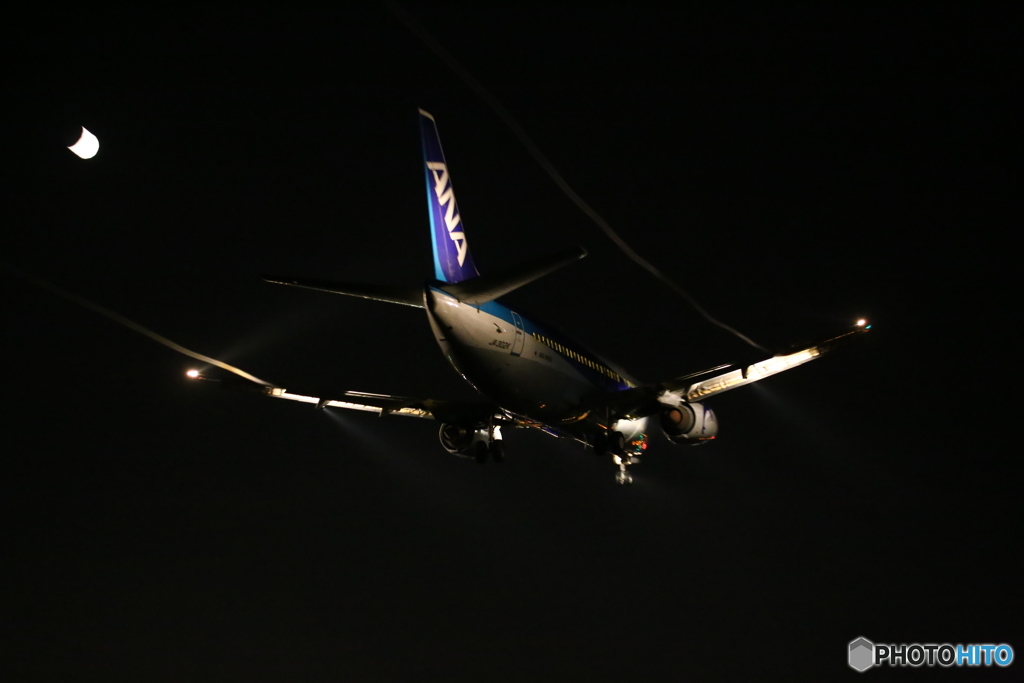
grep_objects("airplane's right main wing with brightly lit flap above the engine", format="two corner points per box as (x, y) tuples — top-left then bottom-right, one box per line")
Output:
(595, 321), (871, 418)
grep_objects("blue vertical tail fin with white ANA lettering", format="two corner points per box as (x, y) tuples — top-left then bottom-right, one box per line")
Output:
(420, 110), (480, 283)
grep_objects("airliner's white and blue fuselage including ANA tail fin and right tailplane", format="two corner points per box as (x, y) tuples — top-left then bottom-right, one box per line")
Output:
(415, 110), (643, 443)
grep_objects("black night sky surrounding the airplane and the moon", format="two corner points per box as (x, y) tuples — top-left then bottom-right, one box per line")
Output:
(0, 4), (1024, 681)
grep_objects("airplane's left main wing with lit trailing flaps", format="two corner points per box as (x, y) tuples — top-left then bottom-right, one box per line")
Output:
(187, 370), (498, 422)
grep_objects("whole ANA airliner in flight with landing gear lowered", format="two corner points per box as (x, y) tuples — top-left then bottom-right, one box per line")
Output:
(187, 110), (871, 484)
